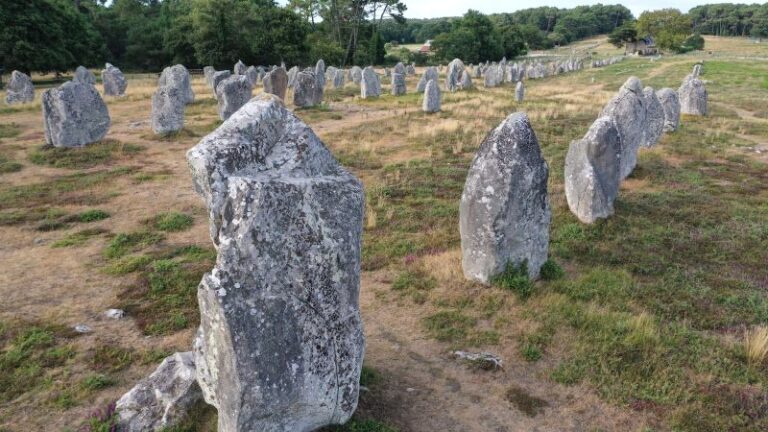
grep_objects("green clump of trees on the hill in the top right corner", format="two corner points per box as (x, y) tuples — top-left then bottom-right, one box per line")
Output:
(688, 3), (768, 37)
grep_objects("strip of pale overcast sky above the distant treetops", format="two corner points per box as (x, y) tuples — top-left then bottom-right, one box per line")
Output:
(278, 0), (708, 18)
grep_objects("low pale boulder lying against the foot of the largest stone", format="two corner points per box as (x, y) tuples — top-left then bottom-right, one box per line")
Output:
(115, 352), (203, 432)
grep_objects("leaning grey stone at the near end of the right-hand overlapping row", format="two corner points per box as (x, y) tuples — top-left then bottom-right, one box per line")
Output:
(565, 117), (621, 223)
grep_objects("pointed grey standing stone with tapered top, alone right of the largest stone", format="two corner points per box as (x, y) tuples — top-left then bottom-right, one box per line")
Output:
(459, 112), (552, 284)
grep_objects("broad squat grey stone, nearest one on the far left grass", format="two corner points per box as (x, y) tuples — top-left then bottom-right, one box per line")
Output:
(42, 81), (110, 147)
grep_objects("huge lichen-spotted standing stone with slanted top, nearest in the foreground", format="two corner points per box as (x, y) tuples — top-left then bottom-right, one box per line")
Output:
(187, 93), (364, 432)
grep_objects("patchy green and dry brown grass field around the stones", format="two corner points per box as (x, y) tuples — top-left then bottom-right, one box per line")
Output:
(0, 38), (768, 432)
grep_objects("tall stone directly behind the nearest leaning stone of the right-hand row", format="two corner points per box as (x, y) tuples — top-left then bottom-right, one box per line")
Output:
(601, 77), (648, 180)
